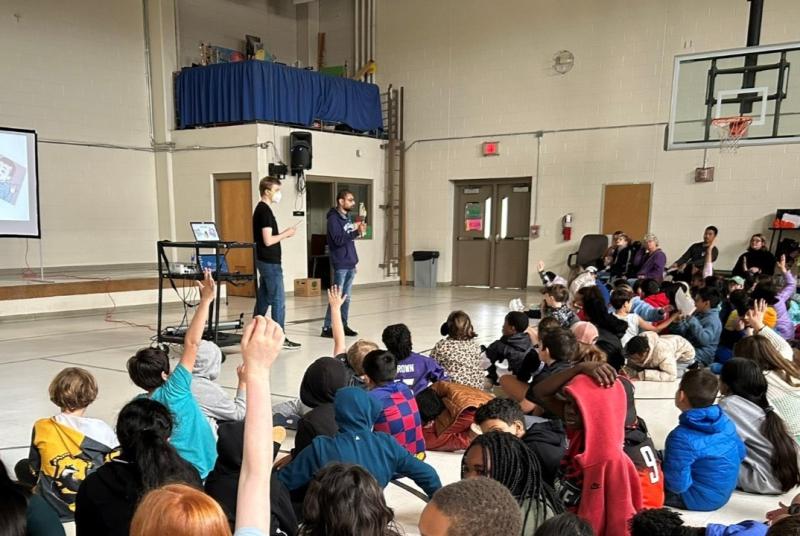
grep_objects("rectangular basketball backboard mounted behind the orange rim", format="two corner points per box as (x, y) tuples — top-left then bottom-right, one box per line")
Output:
(665, 43), (800, 150)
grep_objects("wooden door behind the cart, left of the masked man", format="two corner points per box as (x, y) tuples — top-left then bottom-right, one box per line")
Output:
(216, 177), (256, 298)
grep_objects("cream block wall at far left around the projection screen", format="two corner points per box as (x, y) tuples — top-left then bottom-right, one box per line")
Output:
(0, 0), (157, 268)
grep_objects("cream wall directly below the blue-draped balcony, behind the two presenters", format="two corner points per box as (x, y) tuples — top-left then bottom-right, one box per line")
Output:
(173, 124), (388, 289)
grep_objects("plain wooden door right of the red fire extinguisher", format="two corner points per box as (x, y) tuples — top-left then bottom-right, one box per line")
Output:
(601, 183), (653, 241)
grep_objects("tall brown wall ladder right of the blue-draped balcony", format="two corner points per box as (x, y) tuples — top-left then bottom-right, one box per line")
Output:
(380, 86), (406, 284)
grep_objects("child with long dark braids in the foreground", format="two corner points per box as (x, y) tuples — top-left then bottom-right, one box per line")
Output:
(461, 432), (564, 536)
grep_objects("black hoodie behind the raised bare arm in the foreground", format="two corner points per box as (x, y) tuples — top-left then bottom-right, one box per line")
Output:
(206, 421), (297, 536)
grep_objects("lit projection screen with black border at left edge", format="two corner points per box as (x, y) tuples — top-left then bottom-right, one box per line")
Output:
(0, 128), (40, 237)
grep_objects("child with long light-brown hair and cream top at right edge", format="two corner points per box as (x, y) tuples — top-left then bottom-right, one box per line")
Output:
(733, 335), (800, 442)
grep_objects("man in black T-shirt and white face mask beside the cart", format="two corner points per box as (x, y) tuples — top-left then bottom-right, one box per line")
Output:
(253, 177), (300, 350)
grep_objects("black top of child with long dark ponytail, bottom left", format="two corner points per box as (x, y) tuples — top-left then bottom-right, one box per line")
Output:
(75, 458), (201, 536)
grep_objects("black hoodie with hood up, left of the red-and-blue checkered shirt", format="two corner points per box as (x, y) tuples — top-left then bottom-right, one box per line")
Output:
(292, 357), (348, 457)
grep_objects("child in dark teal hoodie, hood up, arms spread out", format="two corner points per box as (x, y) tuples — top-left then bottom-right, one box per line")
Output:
(278, 387), (442, 497)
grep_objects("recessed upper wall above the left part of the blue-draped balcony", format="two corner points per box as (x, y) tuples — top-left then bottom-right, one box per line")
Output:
(178, 0), (297, 67)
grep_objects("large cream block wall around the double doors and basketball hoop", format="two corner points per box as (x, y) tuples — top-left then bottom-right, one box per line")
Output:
(376, 0), (800, 284)
